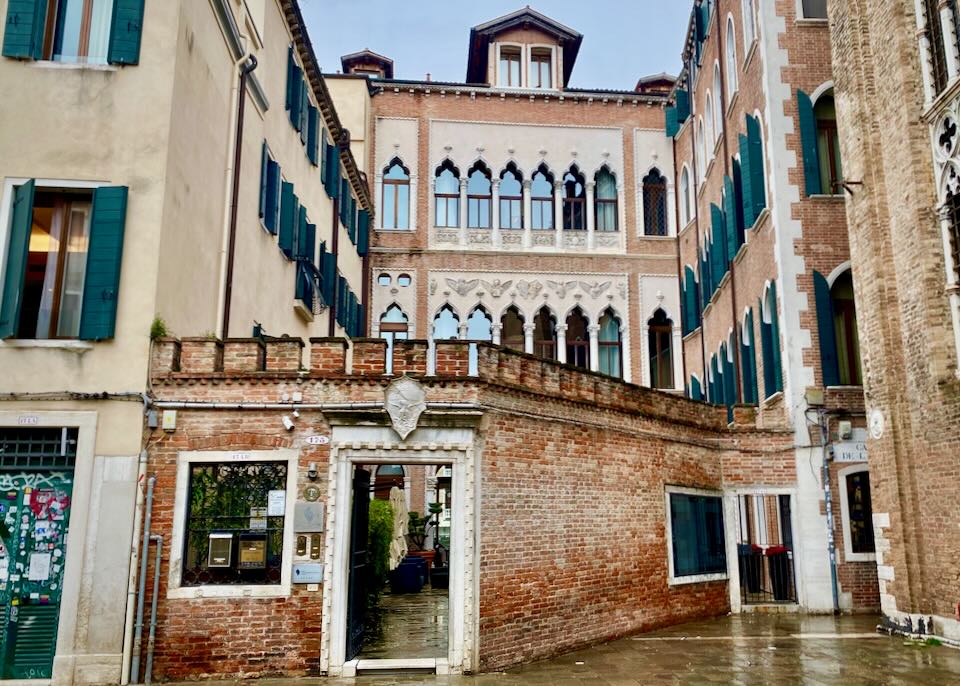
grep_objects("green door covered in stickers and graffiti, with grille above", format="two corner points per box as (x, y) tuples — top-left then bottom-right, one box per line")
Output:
(0, 428), (77, 679)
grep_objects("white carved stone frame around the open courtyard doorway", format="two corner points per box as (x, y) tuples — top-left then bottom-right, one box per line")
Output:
(320, 436), (479, 676)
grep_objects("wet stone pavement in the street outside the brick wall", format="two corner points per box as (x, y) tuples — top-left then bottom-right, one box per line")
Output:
(336, 614), (960, 686)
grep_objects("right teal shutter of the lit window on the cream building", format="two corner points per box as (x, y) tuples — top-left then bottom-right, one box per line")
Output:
(80, 186), (127, 341)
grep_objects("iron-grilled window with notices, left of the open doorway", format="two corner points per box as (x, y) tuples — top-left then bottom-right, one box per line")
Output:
(181, 462), (287, 586)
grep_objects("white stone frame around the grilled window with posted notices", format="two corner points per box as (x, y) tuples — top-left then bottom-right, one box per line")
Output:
(167, 448), (299, 599)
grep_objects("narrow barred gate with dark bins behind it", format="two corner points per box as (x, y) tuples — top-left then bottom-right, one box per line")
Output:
(737, 494), (797, 605)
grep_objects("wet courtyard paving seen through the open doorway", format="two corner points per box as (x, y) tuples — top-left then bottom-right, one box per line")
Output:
(360, 586), (449, 660)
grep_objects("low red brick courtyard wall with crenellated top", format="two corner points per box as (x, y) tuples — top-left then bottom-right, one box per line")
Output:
(148, 339), (795, 680)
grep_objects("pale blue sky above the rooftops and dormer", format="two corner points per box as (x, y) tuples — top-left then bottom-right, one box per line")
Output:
(300, 0), (693, 90)
